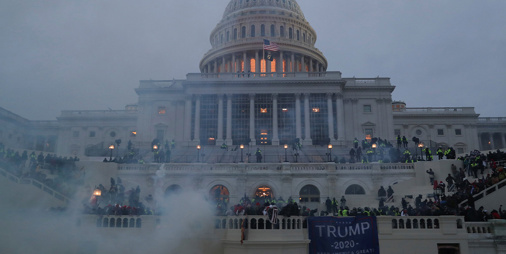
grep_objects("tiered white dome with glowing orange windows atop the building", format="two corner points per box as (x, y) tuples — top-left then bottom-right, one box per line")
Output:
(200, 0), (327, 75)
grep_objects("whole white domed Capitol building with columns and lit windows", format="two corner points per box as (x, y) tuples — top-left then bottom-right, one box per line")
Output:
(0, 0), (506, 253)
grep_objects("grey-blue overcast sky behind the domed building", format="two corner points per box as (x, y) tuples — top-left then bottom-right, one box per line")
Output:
(0, 0), (506, 120)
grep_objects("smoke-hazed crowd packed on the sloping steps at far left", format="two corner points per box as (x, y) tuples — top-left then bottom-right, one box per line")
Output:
(0, 143), (84, 196)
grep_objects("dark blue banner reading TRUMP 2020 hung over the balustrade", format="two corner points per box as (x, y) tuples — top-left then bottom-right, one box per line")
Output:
(308, 217), (379, 254)
